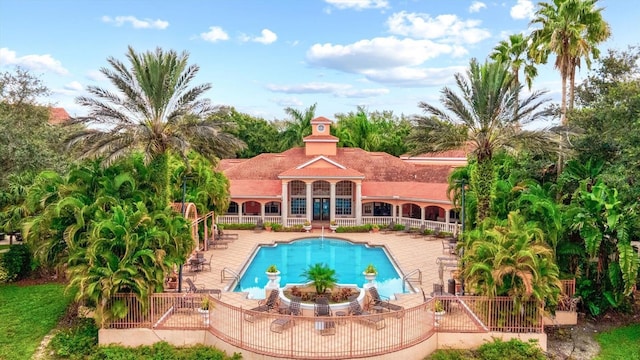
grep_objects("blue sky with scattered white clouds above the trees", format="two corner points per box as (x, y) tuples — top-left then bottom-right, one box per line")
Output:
(0, 0), (640, 120)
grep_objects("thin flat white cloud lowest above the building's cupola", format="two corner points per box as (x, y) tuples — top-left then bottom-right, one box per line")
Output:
(266, 82), (389, 97)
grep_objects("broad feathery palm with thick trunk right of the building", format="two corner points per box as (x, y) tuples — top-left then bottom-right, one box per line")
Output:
(408, 59), (557, 223)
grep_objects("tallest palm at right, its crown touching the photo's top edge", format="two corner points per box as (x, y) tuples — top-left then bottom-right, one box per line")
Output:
(531, 0), (611, 125)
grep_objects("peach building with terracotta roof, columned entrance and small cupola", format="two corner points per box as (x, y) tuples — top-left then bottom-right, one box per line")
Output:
(218, 117), (466, 232)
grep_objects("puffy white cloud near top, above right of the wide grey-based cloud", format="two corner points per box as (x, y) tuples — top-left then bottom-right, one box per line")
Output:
(387, 11), (491, 44)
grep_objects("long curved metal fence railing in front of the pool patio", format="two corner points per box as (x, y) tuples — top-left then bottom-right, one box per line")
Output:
(105, 293), (543, 359)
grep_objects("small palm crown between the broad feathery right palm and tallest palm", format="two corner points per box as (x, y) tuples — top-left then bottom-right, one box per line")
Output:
(489, 34), (538, 89)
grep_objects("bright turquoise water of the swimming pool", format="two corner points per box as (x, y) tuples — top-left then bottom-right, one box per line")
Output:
(234, 238), (403, 299)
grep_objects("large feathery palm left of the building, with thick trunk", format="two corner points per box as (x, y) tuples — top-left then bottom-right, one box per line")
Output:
(68, 47), (239, 207)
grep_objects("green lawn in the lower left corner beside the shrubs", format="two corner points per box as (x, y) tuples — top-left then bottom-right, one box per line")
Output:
(0, 284), (72, 360)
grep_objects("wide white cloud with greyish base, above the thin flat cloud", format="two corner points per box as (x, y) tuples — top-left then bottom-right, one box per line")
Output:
(307, 37), (460, 73)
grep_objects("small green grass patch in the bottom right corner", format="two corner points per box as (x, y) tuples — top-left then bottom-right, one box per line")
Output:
(596, 324), (640, 360)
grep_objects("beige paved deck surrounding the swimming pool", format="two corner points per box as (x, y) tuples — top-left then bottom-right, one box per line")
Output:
(183, 229), (458, 308)
